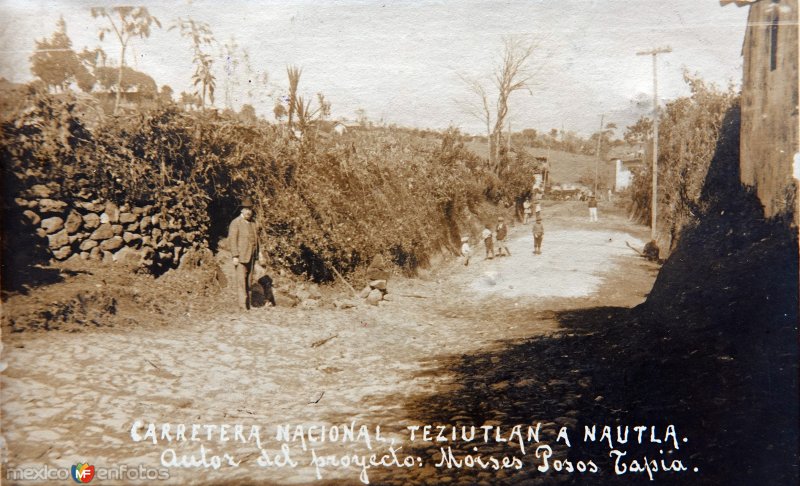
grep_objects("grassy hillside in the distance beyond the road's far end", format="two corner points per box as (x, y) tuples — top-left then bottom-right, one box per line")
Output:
(464, 141), (614, 185)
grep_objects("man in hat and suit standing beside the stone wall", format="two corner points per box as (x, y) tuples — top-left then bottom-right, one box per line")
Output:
(228, 198), (264, 310)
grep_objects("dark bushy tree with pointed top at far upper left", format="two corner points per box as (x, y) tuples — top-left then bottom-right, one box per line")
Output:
(30, 17), (94, 91)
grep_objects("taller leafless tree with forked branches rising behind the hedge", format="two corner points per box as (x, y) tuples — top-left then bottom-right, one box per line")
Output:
(492, 36), (537, 163)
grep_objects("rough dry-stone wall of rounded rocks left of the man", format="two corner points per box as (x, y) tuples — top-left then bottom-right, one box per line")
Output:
(15, 184), (205, 268)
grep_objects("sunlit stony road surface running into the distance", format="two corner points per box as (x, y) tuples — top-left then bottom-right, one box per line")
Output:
(2, 203), (655, 484)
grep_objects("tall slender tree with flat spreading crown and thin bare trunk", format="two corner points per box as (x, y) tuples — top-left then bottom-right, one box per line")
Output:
(91, 7), (161, 114)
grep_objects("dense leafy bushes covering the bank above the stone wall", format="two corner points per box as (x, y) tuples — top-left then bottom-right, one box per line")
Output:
(2, 89), (512, 280)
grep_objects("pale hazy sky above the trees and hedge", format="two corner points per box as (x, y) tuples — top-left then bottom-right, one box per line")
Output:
(0, 0), (748, 136)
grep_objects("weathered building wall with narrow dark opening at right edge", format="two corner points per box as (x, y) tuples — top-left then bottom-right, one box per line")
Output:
(740, 0), (800, 224)
